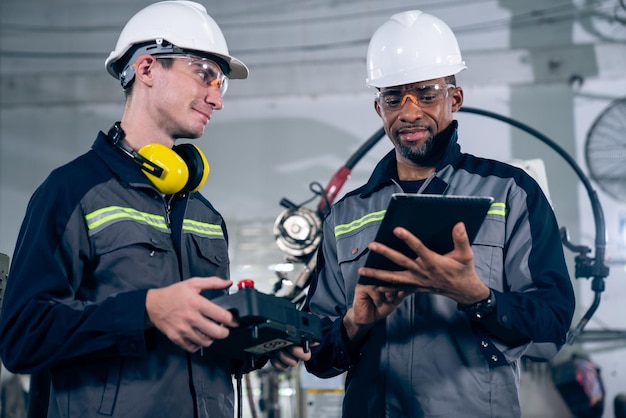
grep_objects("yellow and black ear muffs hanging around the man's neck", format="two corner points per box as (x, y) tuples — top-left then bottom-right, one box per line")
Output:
(108, 122), (209, 194)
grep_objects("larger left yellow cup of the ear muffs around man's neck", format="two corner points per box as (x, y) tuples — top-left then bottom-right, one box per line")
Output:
(137, 144), (189, 194)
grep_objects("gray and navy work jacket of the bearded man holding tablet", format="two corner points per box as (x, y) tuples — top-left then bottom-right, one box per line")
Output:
(306, 122), (574, 418)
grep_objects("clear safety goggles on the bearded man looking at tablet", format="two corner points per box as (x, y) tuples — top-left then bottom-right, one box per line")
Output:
(376, 84), (456, 111)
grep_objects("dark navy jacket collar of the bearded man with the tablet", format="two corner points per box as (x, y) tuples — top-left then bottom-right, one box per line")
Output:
(360, 120), (461, 198)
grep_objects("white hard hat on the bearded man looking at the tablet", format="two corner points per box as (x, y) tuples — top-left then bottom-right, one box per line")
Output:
(366, 10), (467, 88)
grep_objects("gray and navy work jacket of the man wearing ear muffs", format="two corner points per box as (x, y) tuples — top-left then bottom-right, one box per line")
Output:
(0, 133), (235, 418)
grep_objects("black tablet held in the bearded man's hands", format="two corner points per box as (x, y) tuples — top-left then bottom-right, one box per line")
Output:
(359, 193), (493, 284)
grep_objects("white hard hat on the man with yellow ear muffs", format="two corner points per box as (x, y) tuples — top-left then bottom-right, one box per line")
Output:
(105, 0), (248, 86)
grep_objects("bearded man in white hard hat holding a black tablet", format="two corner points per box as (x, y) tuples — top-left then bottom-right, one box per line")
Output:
(306, 10), (574, 418)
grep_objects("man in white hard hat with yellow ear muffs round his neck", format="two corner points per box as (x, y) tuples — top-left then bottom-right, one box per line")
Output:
(0, 1), (310, 418)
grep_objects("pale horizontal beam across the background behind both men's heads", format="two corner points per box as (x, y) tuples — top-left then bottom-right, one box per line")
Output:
(0, 43), (626, 108)
